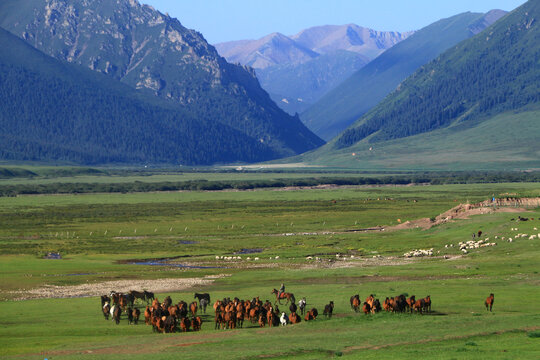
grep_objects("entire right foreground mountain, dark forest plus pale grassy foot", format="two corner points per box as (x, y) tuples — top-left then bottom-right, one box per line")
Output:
(306, 1), (540, 169)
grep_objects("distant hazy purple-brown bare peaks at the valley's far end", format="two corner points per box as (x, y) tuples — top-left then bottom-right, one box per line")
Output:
(215, 24), (412, 114)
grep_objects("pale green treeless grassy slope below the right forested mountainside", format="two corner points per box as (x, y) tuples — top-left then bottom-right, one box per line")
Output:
(303, 107), (540, 170)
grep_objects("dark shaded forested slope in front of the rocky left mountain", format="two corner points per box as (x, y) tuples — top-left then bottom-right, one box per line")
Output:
(0, 28), (276, 165)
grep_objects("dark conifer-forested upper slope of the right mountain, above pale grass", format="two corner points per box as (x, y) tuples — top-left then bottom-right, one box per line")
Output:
(333, 1), (540, 148)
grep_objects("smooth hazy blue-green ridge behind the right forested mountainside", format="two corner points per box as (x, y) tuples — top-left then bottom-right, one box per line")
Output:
(301, 10), (505, 140)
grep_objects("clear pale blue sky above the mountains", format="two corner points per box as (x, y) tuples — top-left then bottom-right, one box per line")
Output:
(139, 0), (537, 44)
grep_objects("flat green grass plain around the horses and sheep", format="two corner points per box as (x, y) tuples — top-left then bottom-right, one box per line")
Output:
(0, 183), (540, 359)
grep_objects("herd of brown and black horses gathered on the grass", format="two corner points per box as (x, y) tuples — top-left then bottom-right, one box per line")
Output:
(101, 289), (495, 333)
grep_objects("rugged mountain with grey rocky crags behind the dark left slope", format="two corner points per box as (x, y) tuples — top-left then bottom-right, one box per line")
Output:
(0, 0), (323, 156)
